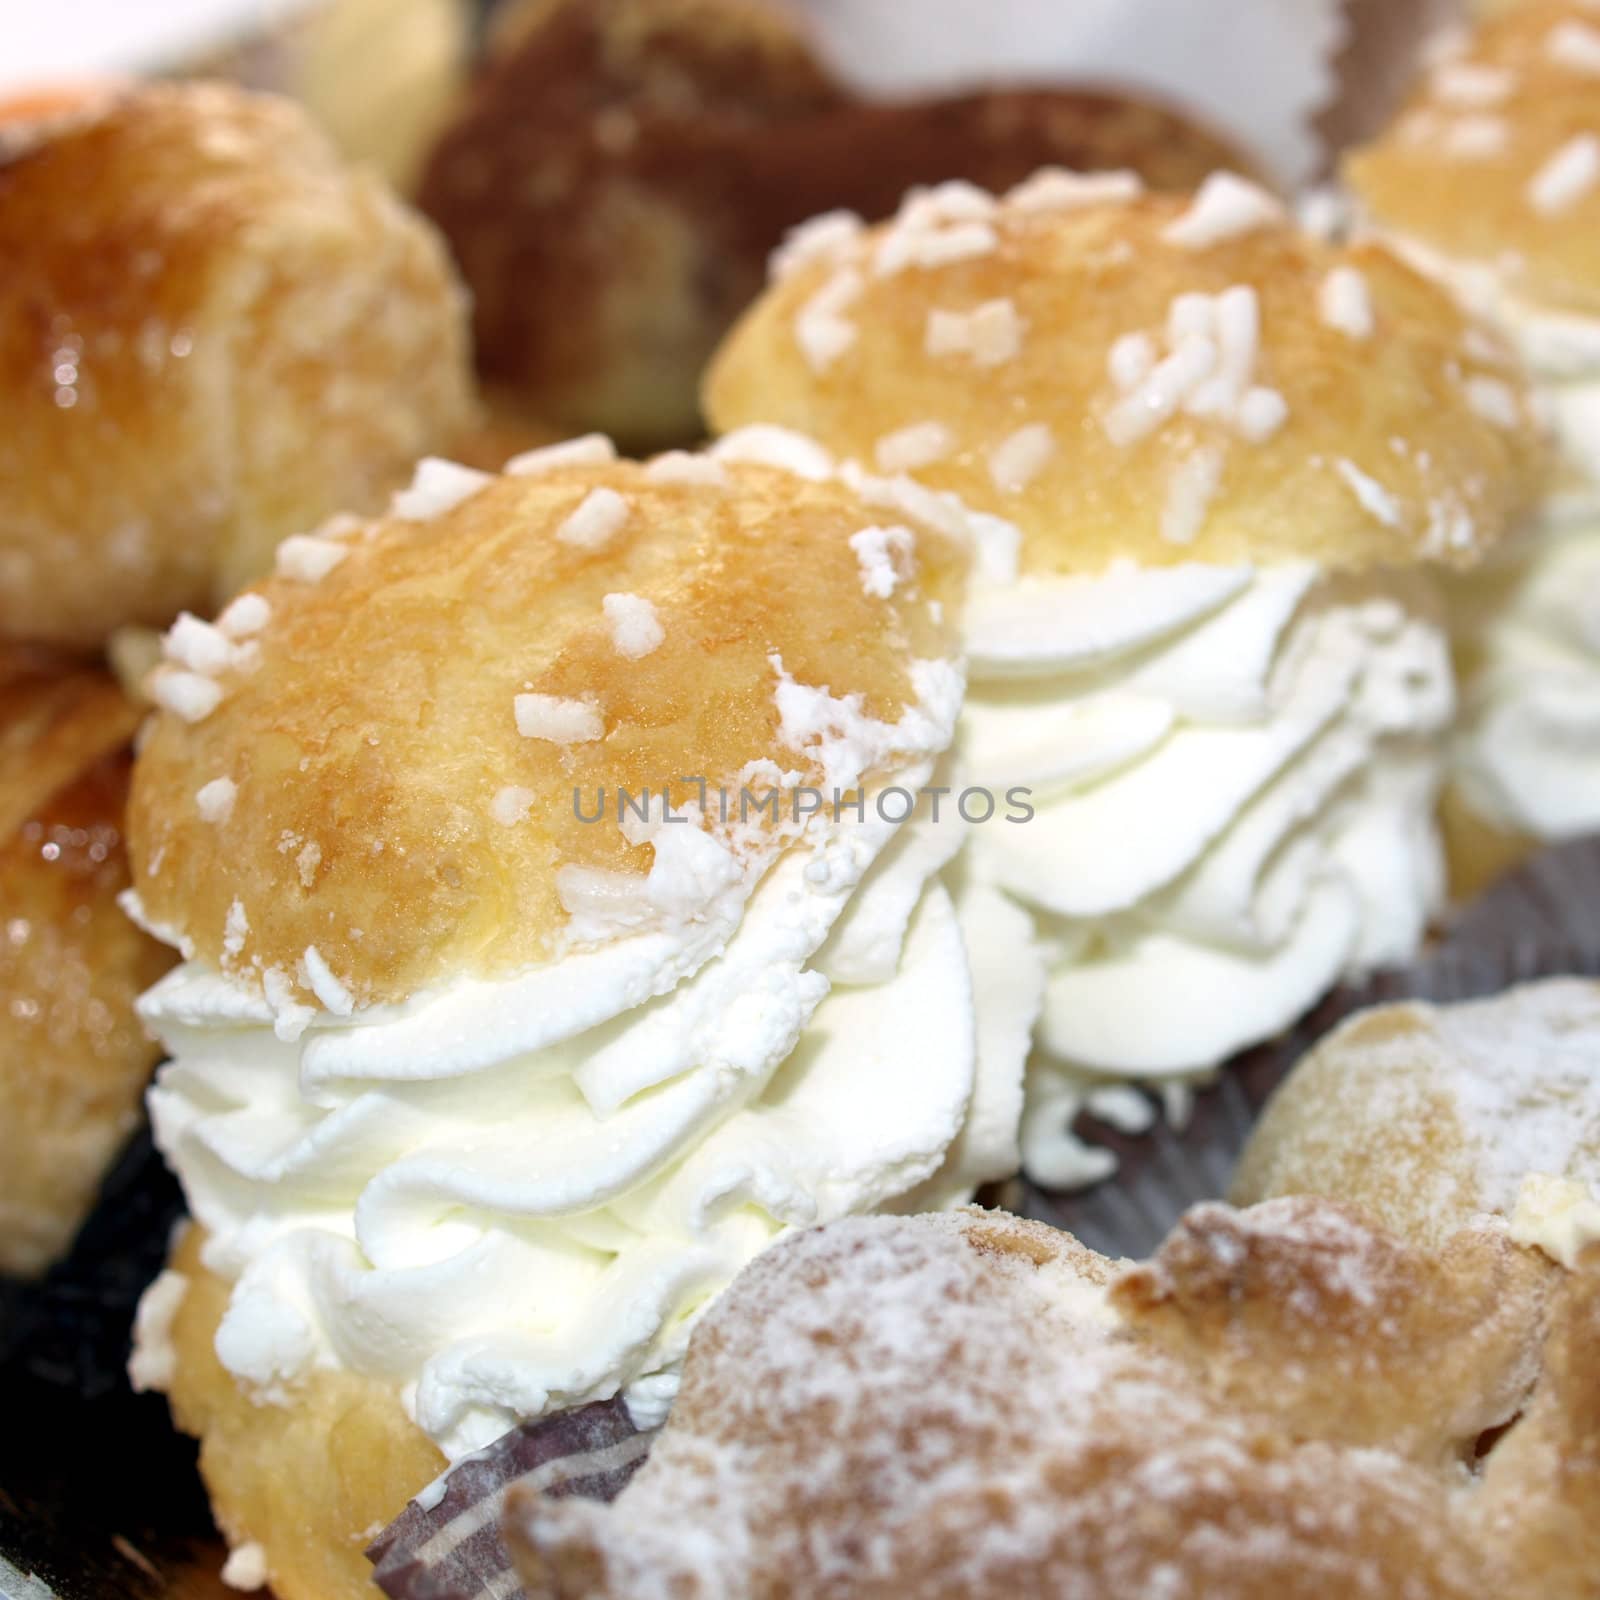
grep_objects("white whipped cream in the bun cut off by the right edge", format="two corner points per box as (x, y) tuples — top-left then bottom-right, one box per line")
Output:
(1403, 243), (1600, 840)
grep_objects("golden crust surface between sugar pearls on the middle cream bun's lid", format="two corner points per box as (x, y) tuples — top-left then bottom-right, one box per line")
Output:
(706, 186), (1544, 573)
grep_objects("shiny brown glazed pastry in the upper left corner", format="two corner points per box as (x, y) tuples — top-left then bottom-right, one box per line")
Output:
(0, 85), (472, 648)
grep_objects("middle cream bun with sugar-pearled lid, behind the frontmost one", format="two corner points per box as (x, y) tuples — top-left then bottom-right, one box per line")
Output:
(707, 173), (1539, 1182)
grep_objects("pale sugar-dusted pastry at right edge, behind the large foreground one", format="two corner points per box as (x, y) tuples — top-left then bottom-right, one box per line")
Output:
(1234, 978), (1600, 1256)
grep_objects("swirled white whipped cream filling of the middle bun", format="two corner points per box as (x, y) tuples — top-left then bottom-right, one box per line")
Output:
(962, 563), (1453, 1182)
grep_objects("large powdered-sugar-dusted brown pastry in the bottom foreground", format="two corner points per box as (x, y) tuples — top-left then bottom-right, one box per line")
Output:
(507, 1200), (1600, 1600)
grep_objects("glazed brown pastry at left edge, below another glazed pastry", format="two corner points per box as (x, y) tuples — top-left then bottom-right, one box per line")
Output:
(0, 645), (171, 1277)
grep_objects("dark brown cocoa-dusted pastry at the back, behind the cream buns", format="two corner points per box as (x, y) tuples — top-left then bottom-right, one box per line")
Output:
(421, 0), (1234, 445)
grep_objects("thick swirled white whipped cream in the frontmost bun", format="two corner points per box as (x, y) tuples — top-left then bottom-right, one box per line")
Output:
(142, 662), (1027, 1459)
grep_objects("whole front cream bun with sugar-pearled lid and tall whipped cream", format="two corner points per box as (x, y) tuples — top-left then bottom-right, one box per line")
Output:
(130, 438), (1026, 1600)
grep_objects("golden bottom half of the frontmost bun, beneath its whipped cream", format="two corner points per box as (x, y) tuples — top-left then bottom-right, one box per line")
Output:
(168, 1227), (445, 1600)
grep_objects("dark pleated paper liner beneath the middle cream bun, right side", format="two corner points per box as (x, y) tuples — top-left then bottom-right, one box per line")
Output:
(1008, 837), (1600, 1258)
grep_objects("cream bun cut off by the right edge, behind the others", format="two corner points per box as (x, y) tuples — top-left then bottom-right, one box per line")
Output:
(1347, 0), (1600, 891)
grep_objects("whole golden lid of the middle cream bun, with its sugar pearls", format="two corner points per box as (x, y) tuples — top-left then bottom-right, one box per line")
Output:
(706, 174), (1544, 573)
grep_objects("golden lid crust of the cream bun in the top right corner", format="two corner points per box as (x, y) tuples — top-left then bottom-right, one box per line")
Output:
(1346, 0), (1600, 315)
